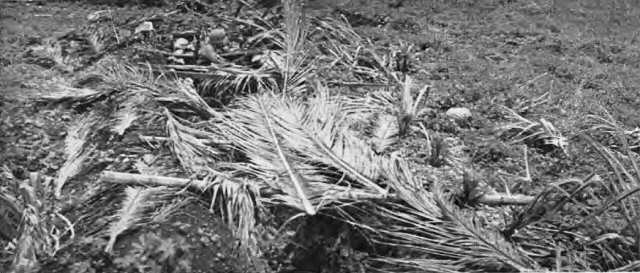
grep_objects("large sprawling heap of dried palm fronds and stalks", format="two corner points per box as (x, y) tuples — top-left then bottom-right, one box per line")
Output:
(0, 0), (640, 272)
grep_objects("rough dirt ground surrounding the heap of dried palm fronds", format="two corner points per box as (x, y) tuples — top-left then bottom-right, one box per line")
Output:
(0, 0), (640, 272)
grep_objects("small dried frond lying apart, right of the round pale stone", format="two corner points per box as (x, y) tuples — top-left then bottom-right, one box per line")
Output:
(499, 107), (569, 154)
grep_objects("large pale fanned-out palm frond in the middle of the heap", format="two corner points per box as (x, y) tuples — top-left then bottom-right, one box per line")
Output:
(220, 87), (386, 209)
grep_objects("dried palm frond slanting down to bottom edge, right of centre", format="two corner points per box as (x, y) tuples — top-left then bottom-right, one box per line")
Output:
(362, 156), (536, 272)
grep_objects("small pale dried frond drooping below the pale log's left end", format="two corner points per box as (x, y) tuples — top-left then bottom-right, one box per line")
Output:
(105, 187), (174, 252)
